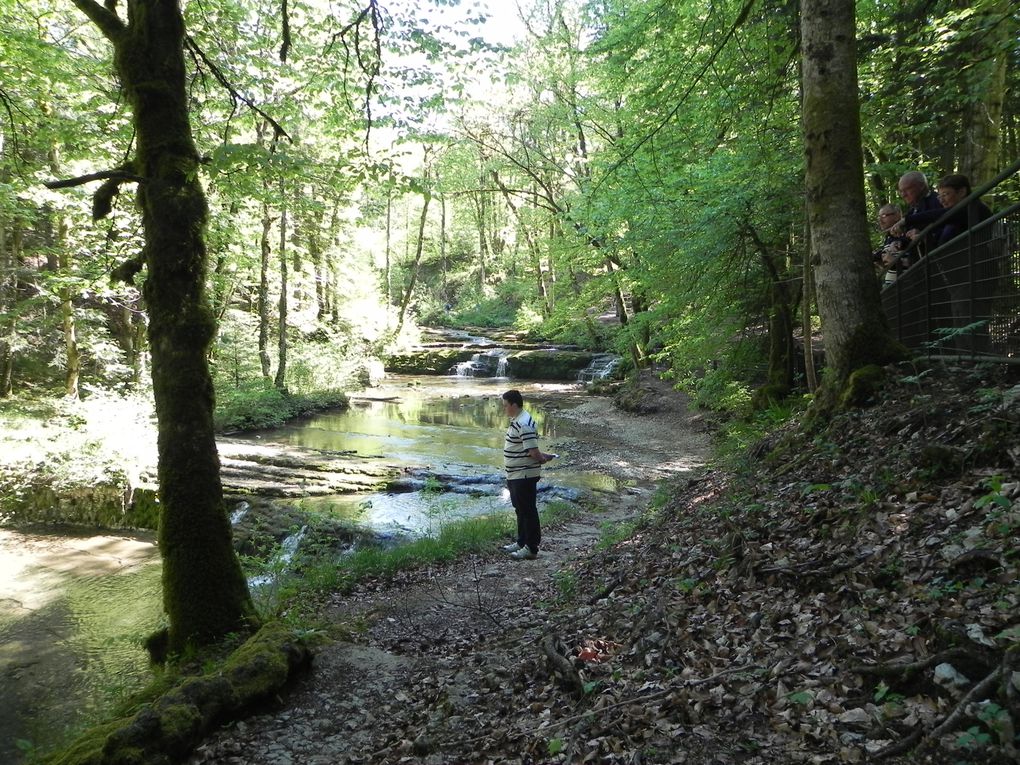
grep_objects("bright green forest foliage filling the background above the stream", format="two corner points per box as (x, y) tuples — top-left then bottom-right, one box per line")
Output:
(0, 0), (1020, 406)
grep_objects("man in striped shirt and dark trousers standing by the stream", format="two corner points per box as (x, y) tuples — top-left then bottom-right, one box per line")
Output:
(503, 391), (554, 560)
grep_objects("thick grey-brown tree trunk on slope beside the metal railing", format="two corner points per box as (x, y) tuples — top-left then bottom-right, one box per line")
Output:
(801, 0), (899, 410)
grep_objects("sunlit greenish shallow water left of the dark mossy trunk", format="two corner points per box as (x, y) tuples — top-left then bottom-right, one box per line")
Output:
(0, 529), (162, 763)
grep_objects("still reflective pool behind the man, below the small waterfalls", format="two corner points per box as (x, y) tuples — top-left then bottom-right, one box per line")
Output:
(245, 376), (619, 533)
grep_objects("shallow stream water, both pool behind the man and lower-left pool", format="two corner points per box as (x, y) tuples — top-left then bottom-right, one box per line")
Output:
(0, 376), (617, 763)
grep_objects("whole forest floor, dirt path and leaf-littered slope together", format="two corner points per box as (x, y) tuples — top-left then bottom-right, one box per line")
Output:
(189, 368), (1020, 765)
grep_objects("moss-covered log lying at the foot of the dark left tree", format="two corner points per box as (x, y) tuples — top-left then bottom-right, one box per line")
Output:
(44, 622), (311, 765)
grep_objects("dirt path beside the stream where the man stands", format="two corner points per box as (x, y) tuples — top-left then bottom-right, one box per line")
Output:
(189, 380), (708, 765)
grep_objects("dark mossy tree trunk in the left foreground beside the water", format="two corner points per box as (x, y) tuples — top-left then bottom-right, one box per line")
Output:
(73, 0), (256, 653)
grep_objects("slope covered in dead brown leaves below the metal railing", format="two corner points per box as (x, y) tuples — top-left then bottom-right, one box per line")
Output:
(510, 373), (1020, 763)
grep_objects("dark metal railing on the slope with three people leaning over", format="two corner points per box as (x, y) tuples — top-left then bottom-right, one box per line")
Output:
(881, 162), (1020, 363)
